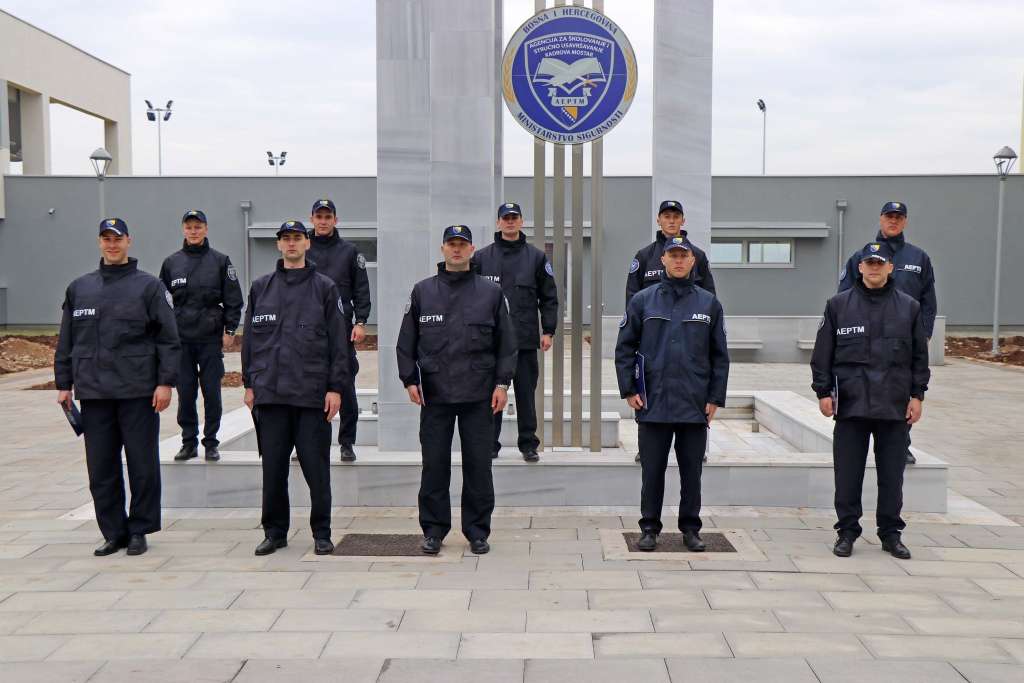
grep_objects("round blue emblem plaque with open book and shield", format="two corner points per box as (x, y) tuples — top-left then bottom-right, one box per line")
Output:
(502, 6), (637, 144)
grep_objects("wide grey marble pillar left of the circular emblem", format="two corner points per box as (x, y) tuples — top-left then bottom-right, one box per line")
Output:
(375, 0), (502, 451)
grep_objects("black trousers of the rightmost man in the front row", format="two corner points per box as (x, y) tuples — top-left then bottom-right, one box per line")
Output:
(833, 419), (907, 539)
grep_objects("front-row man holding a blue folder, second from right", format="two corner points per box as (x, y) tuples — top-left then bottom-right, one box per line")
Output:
(615, 236), (729, 552)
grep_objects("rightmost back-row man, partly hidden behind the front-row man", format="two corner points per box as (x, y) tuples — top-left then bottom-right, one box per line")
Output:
(839, 202), (939, 465)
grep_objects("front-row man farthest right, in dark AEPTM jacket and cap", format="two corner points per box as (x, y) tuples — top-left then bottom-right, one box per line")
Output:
(811, 242), (930, 559)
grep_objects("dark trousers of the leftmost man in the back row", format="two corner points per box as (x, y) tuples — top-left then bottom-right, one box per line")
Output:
(177, 340), (224, 449)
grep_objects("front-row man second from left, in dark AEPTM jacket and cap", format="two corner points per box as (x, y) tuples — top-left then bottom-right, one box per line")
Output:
(242, 220), (351, 555)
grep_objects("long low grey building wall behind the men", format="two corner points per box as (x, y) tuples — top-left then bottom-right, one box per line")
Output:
(0, 175), (1024, 325)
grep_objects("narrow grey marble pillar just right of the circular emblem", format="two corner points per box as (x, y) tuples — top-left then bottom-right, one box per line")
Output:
(651, 0), (714, 251)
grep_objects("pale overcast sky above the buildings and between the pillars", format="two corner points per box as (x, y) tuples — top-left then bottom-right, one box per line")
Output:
(0, 0), (1024, 175)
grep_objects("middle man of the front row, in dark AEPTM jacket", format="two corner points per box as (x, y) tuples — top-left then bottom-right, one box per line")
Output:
(396, 225), (518, 555)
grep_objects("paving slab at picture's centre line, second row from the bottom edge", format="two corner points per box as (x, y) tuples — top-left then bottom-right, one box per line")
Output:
(459, 633), (594, 659)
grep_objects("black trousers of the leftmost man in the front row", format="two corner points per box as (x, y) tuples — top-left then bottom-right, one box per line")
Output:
(82, 396), (160, 541)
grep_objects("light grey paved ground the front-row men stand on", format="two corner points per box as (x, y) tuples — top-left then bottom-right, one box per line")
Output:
(0, 354), (1024, 683)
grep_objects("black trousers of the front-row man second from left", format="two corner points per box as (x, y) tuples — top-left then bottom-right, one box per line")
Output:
(256, 403), (331, 540)
